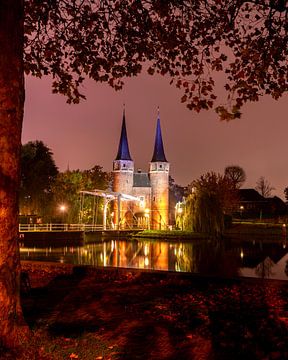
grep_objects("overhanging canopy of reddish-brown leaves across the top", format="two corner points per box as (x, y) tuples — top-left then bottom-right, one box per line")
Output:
(24, 0), (288, 120)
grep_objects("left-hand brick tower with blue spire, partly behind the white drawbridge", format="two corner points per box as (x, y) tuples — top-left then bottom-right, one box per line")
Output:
(113, 110), (134, 228)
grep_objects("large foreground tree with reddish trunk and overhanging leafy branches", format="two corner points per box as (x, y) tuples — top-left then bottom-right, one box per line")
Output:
(0, 0), (288, 345)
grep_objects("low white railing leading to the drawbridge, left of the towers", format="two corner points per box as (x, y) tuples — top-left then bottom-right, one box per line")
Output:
(19, 224), (103, 232)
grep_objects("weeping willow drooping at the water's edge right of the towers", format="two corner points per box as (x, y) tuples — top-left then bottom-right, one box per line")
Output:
(184, 172), (237, 237)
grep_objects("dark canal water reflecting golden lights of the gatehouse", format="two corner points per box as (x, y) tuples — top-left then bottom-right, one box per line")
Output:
(20, 239), (288, 280)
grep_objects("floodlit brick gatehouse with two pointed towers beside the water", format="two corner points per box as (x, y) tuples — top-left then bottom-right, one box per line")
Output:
(113, 109), (169, 229)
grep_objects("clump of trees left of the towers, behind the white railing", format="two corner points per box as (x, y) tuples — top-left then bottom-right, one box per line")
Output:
(20, 141), (111, 223)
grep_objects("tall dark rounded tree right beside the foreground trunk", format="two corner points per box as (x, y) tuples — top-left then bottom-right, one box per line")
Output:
(20, 141), (58, 217)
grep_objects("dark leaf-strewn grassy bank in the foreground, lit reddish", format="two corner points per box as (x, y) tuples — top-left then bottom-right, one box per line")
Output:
(0, 262), (288, 360)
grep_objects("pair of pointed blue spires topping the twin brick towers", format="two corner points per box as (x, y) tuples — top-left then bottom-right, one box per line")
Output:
(115, 109), (167, 162)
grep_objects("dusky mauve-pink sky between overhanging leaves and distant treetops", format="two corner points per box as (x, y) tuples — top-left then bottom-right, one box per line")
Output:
(22, 73), (288, 199)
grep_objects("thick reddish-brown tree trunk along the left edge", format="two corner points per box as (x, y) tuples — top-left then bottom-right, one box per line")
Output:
(0, 0), (28, 347)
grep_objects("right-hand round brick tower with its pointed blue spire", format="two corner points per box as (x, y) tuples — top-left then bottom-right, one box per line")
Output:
(149, 111), (170, 229)
